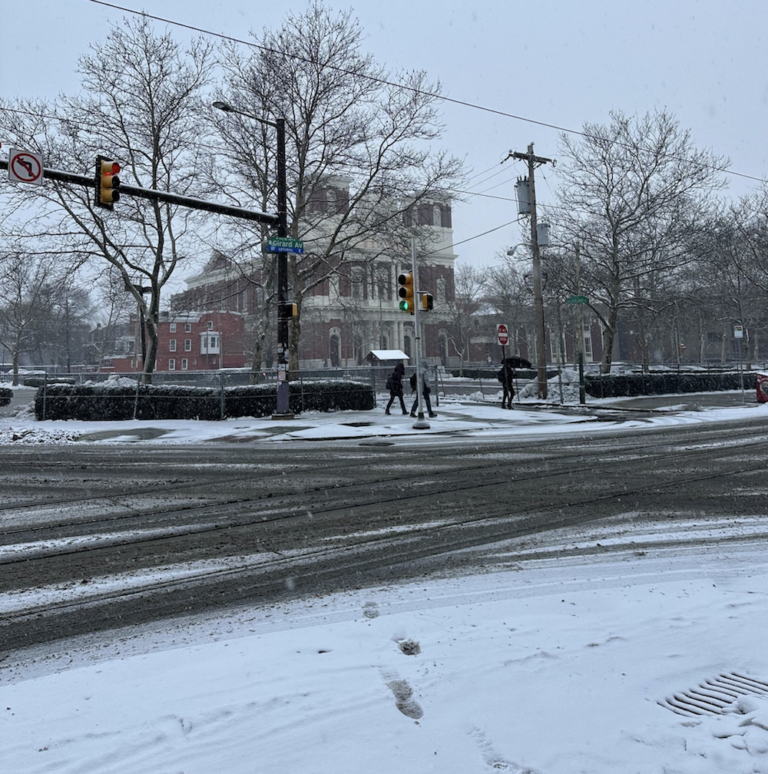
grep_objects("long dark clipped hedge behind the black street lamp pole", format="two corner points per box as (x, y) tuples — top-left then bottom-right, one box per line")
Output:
(35, 379), (376, 421)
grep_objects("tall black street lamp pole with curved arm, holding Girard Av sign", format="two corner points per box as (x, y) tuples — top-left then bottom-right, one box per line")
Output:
(211, 100), (291, 417)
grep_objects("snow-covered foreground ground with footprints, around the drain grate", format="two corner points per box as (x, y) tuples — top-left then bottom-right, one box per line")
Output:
(0, 536), (768, 774)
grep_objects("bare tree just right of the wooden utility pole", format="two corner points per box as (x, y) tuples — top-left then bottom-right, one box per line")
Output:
(558, 111), (725, 373)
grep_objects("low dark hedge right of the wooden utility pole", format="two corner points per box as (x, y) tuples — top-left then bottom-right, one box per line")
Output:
(584, 371), (755, 398)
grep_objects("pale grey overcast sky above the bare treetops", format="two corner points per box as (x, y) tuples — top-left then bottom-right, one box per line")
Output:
(0, 0), (768, 272)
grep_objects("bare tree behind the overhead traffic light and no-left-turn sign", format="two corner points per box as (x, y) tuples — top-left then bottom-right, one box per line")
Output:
(0, 18), (211, 381)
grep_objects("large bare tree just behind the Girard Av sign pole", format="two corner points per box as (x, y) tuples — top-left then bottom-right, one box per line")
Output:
(207, 0), (461, 371)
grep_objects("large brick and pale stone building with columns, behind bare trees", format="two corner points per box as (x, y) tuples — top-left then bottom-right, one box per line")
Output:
(171, 185), (458, 369)
